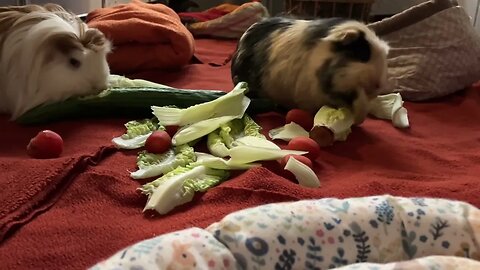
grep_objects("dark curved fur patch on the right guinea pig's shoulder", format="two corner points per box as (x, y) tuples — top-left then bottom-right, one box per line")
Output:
(316, 58), (357, 107)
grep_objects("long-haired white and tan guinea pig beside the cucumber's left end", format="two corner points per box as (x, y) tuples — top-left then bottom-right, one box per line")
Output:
(0, 4), (111, 120)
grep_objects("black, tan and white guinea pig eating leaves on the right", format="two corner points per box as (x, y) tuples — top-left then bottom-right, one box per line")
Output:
(231, 17), (389, 124)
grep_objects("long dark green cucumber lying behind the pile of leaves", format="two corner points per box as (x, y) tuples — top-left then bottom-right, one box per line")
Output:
(15, 87), (277, 125)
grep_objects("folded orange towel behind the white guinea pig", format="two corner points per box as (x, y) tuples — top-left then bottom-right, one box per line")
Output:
(87, 0), (195, 74)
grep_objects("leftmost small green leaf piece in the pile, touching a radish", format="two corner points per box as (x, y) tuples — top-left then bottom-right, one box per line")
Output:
(112, 117), (165, 149)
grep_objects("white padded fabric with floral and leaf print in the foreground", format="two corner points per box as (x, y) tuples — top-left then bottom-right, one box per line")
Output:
(91, 195), (480, 270)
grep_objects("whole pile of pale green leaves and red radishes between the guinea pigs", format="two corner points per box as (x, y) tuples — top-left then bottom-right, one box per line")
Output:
(112, 82), (409, 214)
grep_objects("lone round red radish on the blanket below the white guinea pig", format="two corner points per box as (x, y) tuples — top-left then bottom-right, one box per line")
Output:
(27, 130), (63, 159)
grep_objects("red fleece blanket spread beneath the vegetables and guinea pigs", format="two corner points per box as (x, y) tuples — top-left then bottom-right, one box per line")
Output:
(0, 39), (480, 269)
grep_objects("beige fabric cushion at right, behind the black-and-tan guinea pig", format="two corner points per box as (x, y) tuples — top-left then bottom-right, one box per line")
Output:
(372, 2), (480, 101)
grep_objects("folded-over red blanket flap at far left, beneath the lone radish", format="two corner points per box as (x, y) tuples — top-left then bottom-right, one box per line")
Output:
(0, 118), (125, 243)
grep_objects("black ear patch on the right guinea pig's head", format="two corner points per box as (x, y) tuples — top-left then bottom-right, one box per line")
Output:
(334, 31), (372, 62)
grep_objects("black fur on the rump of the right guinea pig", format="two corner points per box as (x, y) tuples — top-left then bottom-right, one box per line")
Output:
(231, 17), (294, 96)
